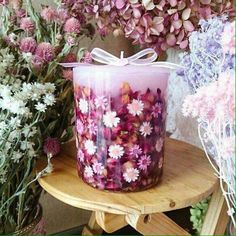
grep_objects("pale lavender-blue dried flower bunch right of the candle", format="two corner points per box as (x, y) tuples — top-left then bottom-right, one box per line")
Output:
(177, 17), (234, 91)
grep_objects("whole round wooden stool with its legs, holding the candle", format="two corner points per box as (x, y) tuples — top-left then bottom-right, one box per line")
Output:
(38, 139), (229, 235)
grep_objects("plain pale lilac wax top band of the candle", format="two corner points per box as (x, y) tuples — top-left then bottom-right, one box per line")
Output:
(73, 64), (170, 96)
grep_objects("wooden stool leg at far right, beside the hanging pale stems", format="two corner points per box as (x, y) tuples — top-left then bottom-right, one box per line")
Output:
(201, 183), (229, 235)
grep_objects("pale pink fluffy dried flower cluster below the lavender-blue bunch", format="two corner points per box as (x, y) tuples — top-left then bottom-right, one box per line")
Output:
(182, 70), (235, 122)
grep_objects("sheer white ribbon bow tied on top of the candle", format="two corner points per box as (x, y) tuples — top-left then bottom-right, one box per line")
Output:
(60, 48), (182, 69)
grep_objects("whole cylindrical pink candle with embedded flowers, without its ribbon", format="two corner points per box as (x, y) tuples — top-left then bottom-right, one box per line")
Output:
(73, 65), (170, 191)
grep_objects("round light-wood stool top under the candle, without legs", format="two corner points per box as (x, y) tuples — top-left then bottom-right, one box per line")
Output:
(38, 138), (217, 214)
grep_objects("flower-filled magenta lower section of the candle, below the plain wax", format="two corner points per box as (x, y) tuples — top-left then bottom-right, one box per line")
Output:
(75, 83), (166, 191)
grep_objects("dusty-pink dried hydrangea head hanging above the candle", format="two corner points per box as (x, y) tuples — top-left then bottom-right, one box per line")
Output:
(87, 0), (234, 52)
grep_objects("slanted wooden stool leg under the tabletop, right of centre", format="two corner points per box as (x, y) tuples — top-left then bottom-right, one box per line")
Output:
(126, 213), (190, 235)
